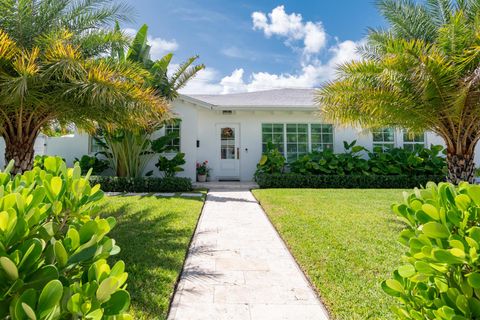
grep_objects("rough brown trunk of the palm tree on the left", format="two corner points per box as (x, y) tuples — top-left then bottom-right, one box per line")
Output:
(4, 135), (36, 174)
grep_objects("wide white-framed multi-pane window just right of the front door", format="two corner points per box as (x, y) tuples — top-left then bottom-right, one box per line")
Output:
(262, 123), (333, 162)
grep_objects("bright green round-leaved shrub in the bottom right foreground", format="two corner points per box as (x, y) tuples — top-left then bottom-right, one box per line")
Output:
(382, 183), (480, 319)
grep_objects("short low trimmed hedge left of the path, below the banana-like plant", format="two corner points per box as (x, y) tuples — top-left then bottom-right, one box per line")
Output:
(90, 176), (193, 192)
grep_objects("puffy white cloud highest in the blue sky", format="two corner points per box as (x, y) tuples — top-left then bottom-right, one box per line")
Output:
(252, 6), (327, 55)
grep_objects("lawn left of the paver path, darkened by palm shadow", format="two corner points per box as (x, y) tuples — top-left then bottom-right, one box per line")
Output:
(102, 196), (203, 319)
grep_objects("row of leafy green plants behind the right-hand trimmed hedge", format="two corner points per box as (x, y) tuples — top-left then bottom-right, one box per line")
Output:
(284, 141), (446, 176)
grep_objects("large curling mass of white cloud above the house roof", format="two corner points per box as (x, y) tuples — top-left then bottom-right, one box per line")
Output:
(182, 6), (363, 94)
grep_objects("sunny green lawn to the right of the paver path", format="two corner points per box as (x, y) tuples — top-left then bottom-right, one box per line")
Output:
(254, 189), (404, 319)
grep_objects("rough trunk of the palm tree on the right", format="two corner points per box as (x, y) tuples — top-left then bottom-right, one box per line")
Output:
(447, 152), (475, 184)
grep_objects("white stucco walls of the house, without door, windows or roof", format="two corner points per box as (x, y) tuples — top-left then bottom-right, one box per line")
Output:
(0, 100), (480, 181)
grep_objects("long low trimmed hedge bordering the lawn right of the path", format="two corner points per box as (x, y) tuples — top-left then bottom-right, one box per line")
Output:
(255, 173), (446, 189)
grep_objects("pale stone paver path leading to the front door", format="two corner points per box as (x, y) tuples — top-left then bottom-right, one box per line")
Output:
(168, 190), (328, 320)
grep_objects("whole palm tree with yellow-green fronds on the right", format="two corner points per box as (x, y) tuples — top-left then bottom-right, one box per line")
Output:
(317, 0), (480, 183)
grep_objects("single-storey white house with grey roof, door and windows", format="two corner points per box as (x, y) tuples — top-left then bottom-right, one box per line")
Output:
(0, 89), (472, 181)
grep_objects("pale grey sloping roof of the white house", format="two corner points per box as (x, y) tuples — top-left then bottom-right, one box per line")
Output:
(188, 89), (315, 109)
